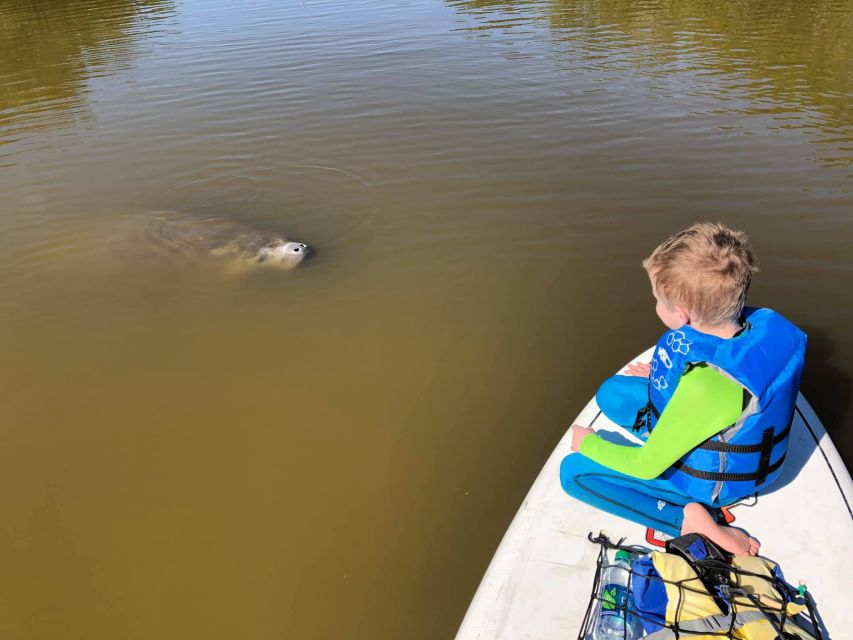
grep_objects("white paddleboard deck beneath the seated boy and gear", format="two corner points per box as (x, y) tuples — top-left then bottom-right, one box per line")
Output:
(456, 349), (853, 640)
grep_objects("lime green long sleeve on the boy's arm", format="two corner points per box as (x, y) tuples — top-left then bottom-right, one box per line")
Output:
(580, 365), (743, 480)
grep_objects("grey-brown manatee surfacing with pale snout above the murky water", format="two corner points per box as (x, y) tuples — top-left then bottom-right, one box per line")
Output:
(148, 214), (311, 269)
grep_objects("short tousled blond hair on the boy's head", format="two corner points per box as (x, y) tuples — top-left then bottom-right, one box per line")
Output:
(643, 222), (758, 326)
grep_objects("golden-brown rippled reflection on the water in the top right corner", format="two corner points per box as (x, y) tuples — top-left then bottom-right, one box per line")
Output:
(447, 0), (853, 165)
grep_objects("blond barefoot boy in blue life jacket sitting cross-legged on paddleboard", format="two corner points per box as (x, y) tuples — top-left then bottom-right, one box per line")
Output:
(560, 223), (806, 555)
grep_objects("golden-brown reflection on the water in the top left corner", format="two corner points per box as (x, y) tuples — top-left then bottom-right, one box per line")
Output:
(0, 0), (175, 143)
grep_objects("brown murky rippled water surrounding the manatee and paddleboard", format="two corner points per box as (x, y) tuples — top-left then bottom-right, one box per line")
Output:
(0, 0), (853, 640)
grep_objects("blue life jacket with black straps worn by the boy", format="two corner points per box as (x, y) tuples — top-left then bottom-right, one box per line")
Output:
(641, 308), (806, 505)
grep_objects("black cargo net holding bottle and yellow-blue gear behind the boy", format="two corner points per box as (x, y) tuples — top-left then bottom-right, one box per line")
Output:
(578, 533), (828, 640)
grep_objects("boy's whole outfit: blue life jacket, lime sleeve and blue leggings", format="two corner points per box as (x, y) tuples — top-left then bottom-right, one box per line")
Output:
(560, 308), (806, 535)
